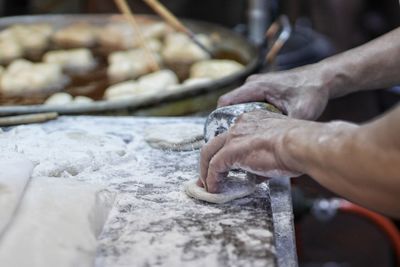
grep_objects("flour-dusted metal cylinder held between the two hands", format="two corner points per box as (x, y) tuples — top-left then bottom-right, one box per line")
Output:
(204, 102), (281, 142)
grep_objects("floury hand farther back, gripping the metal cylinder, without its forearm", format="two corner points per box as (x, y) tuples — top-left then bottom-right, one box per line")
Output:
(218, 64), (329, 120)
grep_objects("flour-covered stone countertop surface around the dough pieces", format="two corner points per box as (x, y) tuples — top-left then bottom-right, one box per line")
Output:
(0, 116), (297, 267)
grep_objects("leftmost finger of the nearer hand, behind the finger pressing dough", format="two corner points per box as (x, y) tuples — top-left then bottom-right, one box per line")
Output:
(200, 133), (227, 189)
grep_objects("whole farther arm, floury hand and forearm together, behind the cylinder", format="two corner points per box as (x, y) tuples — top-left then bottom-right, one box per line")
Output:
(218, 27), (400, 120)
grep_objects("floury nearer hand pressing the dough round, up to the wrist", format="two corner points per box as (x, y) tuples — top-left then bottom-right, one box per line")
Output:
(197, 111), (314, 193)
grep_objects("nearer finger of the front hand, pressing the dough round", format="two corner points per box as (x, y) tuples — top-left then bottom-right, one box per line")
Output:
(206, 148), (235, 193)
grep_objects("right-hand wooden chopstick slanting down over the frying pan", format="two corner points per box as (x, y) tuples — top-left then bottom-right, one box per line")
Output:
(143, 0), (213, 57)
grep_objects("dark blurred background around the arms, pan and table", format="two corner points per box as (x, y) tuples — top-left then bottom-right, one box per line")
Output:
(0, 0), (400, 267)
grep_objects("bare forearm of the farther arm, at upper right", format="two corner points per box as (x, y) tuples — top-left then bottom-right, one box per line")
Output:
(316, 28), (400, 98)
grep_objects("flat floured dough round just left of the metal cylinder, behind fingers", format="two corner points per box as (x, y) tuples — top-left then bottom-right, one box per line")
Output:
(145, 123), (204, 151)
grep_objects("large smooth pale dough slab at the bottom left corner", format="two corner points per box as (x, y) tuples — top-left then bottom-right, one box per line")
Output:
(0, 177), (115, 267)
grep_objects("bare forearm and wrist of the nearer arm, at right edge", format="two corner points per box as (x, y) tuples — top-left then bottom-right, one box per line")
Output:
(283, 106), (400, 217)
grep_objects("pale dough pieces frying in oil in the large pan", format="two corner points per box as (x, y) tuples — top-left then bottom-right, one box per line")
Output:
(0, 22), (243, 103)
